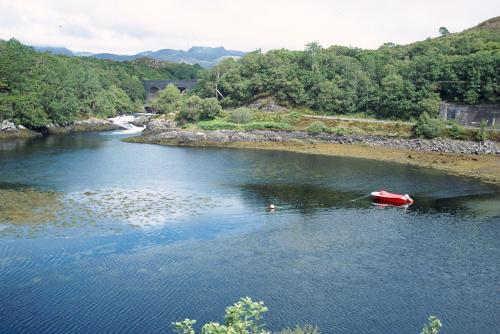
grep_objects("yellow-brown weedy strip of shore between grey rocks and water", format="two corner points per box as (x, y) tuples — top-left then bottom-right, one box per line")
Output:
(123, 133), (500, 186)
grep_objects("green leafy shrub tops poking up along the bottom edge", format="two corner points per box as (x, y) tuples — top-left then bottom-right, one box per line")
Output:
(172, 297), (442, 334)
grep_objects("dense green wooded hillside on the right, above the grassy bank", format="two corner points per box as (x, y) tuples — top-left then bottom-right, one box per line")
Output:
(198, 18), (500, 119)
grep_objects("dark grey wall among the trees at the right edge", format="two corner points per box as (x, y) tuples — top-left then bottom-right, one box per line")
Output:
(439, 102), (500, 128)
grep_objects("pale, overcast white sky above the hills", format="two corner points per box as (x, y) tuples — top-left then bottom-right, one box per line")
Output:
(0, 0), (500, 54)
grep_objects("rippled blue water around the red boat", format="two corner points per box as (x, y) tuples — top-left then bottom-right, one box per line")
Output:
(0, 134), (500, 333)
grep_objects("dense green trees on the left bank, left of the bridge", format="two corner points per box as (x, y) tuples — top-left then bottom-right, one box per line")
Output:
(0, 40), (203, 128)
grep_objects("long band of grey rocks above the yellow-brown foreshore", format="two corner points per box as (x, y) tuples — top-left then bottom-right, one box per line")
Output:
(134, 129), (500, 155)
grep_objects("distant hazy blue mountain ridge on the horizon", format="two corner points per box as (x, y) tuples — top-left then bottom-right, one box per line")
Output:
(30, 46), (245, 68)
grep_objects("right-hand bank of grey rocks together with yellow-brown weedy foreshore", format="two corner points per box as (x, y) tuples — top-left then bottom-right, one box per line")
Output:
(125, 129), (500, 185)
